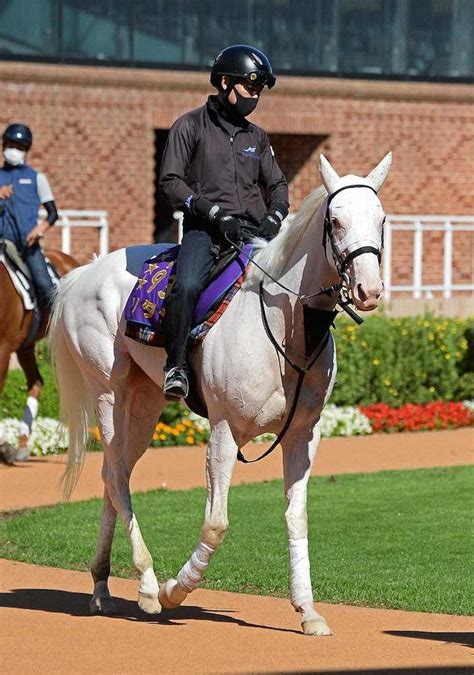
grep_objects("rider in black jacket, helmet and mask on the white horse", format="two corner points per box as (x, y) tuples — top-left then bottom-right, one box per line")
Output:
(160, 45), (289, 399)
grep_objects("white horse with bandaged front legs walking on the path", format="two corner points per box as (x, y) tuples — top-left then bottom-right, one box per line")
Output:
(50, 153), (391, 635)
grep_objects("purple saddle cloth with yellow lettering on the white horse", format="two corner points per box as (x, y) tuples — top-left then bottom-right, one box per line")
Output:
(124, 244), (253, 347)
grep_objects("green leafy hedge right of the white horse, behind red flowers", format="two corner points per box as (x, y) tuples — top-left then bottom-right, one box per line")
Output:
(331, 315), (473, 406)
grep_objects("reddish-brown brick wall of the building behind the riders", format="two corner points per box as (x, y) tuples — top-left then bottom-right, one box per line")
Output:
(0, 62), (474, 296)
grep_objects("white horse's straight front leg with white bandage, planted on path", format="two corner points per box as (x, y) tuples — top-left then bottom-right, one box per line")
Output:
(282, 422), (332, 635)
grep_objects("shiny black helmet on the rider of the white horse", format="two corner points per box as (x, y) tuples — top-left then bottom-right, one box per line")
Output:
(211, 45), (276, 89)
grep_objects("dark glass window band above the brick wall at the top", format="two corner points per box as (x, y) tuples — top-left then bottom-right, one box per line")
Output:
(0, 0), (474, 80)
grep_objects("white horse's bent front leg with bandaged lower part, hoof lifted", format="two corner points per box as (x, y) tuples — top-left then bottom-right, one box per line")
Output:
(160, 422), (237, 609)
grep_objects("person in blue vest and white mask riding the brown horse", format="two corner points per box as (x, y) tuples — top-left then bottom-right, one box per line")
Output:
(0, 124), (58, 311)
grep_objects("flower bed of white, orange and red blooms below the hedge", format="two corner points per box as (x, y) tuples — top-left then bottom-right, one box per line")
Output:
(0, 401), (474, 456)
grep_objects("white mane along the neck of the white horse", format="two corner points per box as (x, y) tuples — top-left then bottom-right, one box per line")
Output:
(248, 185), (327, 281)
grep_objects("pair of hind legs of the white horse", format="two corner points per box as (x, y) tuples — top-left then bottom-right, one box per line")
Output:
(92, 364), (163, 613)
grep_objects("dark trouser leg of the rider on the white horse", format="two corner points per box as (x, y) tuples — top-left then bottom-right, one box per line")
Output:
(165, 230), (214, 368)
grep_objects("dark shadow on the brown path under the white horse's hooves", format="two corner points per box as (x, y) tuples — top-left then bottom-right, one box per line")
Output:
(0, 588), (302, 635)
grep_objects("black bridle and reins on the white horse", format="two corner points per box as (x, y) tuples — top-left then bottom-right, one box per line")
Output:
(225, 184), (383, 464)
